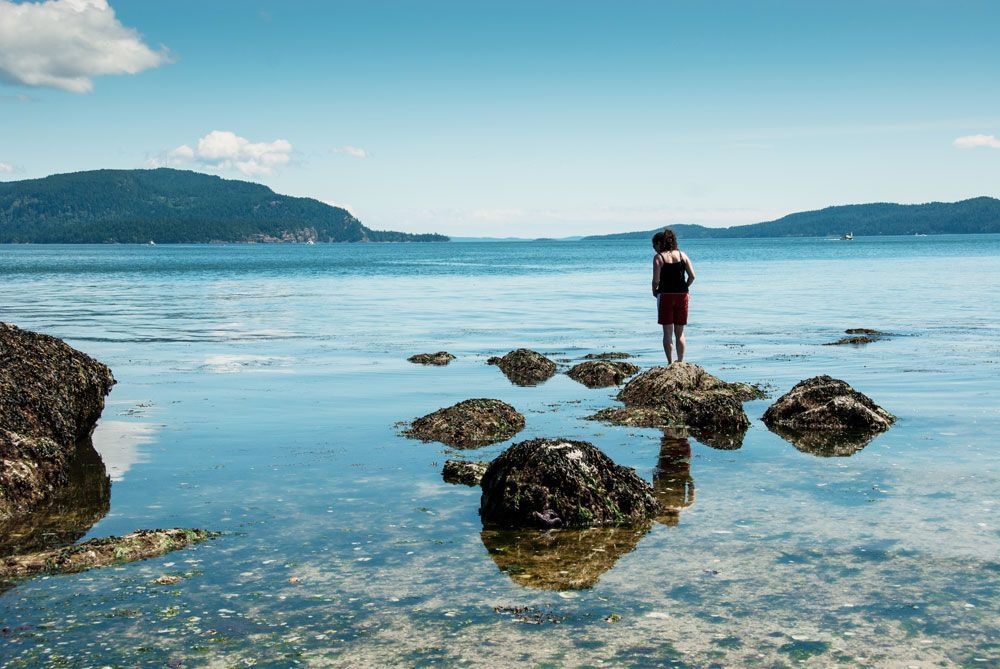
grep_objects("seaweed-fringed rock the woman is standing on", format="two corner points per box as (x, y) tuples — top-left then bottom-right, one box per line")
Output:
(589, 362), (764, 449)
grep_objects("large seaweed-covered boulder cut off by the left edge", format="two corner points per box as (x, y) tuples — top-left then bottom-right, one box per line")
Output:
(0, 323), (115, 519)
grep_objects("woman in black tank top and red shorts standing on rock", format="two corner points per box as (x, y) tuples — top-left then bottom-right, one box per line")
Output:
(653, 228), (694, 364)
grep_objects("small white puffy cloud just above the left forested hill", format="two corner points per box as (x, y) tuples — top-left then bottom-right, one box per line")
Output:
(146, 130), (292, 176)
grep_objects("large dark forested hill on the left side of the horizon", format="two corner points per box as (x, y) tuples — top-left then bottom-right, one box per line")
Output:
(0, 168), (448, 244)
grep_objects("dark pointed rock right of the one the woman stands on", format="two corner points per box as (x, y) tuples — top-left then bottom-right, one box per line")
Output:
(762, 375), (896, 455)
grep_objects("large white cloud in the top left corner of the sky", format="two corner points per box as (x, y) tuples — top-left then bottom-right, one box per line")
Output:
(0, 0), (170, 93)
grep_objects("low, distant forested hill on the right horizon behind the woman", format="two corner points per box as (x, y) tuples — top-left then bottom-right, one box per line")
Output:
(585, 197), (1000, 240)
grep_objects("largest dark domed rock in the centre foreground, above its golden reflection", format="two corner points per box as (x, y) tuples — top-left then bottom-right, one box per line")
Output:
(479, 439), (659, 528)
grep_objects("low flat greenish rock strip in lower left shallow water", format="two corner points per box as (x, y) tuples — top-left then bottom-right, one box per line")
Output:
(0, 528), (217, 581)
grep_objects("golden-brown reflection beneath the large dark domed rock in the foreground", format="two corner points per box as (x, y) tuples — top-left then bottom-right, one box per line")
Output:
(480, 523), (652, 590)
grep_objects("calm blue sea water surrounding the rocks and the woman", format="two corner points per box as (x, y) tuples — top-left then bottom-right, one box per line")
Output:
(0, 236), (1000, 667)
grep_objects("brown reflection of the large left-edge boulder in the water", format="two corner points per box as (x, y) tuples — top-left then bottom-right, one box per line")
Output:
(0, 438), (111, 557)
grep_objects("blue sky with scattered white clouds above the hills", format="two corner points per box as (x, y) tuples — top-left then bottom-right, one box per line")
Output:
(0, 0), (1000, 237)
